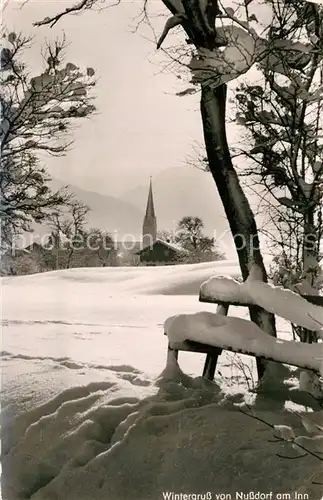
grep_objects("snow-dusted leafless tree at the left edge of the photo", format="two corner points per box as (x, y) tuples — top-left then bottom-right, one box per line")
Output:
(0, 33), (95, 246)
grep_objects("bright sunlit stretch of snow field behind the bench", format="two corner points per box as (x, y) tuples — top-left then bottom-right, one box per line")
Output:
(2, 261), (245, 407)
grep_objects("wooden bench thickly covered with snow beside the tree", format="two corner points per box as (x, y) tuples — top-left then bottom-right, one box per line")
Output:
(164, 273), (323, 380)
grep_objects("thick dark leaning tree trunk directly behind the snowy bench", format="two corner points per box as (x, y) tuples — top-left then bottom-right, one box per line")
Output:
(201, 85), (276, 378)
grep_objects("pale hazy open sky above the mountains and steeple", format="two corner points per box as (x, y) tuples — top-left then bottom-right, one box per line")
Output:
(3, 0), (244, 196)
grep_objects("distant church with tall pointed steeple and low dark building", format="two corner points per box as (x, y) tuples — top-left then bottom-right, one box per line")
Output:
(136, 178), (187, 266)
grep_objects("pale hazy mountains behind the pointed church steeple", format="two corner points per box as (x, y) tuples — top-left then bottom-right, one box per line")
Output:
(29, 166), (235, 256)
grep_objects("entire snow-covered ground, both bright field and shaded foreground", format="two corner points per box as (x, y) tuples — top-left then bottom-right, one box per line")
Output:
(1, 261), (320, 500)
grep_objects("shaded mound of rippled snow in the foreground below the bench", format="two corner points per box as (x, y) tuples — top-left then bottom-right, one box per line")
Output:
(3, 370), (321, 500)
